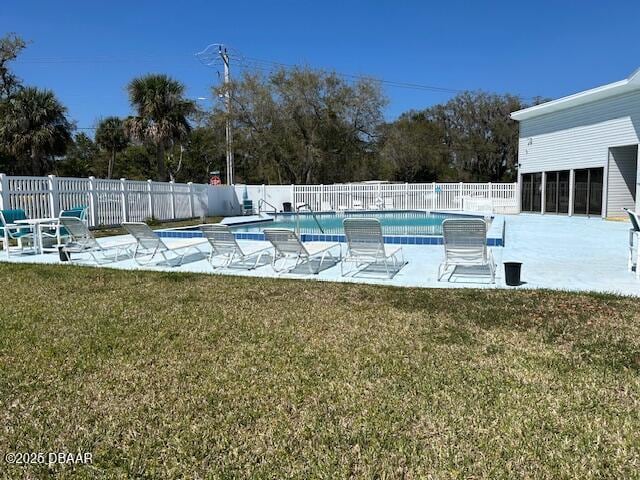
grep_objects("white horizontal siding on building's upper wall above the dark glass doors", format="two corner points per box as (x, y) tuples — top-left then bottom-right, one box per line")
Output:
(518, 90), (640, 173)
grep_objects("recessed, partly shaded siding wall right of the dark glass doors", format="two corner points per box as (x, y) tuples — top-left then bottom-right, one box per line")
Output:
(606, 146), (638, 217)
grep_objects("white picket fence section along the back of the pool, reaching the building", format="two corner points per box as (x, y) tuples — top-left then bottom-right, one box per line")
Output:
(292, 183), (519, 214)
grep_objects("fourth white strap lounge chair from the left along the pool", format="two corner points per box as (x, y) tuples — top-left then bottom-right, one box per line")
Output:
(264, 228), (342, 274)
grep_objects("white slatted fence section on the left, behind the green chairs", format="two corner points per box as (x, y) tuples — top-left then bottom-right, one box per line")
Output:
(0, 174), (209, 227)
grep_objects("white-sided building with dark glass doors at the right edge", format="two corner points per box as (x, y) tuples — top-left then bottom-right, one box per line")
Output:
(511, 70), (640, 217)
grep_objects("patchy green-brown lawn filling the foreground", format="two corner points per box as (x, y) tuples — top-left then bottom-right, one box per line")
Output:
(0, 264), (640, 479)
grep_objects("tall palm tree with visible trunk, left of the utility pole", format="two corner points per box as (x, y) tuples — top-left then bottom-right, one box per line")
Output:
(125, 74), (195, 181)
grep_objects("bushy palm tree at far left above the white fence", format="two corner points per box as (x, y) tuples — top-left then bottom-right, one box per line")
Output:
(0, 87), (72, 175)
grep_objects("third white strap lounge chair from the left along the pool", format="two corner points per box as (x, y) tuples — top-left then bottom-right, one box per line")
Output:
(200, 224), (271, 270)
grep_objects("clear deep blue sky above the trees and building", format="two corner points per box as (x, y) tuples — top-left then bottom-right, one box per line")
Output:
(5, 0), (640, 133)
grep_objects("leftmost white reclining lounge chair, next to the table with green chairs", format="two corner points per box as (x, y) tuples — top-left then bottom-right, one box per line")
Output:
(60, 217), (135, 264)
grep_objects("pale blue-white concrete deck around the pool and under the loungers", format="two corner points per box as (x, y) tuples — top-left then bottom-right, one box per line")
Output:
(0, 214), (640, 296)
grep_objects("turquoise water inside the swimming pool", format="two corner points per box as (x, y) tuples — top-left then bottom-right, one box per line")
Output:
(232, 211), (472, 236)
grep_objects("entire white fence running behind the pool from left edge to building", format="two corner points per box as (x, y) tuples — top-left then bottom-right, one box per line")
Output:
(0, 174), (519, 227)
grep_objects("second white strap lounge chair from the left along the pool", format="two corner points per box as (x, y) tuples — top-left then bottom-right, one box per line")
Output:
(122, 222), (207, 267)
